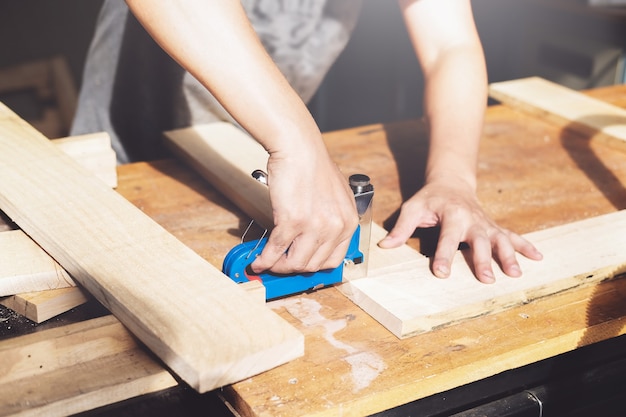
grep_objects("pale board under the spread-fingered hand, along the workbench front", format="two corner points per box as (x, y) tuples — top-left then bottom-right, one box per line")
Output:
(340, 211), (626, 338)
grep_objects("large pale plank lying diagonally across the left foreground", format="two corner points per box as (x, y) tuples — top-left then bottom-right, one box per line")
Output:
(0, 106), (304, 392)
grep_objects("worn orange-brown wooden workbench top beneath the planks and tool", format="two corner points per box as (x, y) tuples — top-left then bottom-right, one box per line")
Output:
(3, 83), (626, 416)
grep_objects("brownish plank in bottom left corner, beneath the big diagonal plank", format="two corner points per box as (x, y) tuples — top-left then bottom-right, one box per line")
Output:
(0, 316), (176, 416)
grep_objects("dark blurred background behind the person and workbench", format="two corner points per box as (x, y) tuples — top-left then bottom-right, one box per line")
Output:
(0, 0), (626, 131)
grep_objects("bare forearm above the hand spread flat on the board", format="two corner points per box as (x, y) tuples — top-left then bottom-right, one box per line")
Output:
(400, 0), (487, 188)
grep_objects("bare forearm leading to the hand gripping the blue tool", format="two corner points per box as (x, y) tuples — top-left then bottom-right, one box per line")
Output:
(127, 0), (321, 153)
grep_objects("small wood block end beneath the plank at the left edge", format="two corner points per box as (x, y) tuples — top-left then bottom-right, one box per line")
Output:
(0, 287), (87, 323)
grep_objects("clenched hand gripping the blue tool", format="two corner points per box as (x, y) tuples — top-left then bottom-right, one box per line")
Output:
(251, 146), (358, 273)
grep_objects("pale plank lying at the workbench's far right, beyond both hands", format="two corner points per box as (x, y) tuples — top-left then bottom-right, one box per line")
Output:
(489, 77), (626, 149)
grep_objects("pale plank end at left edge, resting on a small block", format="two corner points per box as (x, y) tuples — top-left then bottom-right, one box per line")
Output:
(0, 230), (76, 296)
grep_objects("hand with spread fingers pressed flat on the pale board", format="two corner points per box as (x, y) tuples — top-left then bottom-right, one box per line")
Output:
(379, 176), (542, 283)
